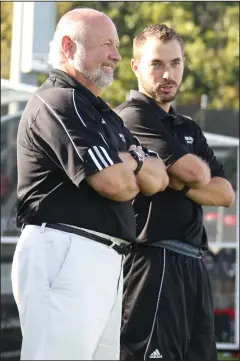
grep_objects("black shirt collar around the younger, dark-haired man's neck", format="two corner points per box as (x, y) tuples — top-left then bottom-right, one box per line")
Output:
(129, 90), (182, 125)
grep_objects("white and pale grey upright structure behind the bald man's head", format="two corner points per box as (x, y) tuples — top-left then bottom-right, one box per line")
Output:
(10, 1), (56, 85)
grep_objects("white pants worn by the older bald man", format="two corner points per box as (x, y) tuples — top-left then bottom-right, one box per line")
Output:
(12, 225), (123, 360)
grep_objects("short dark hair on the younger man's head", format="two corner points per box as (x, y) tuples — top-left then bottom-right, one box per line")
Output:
(133, 24), (184, 59)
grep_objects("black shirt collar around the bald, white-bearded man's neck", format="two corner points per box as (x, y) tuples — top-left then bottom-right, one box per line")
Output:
(49, 69), (111, 110)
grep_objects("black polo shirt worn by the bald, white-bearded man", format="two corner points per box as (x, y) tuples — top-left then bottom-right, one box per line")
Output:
(17, 70), (141, 242)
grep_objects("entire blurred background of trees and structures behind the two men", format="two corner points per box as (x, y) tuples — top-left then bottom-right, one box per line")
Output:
(1, 1), (239, 361)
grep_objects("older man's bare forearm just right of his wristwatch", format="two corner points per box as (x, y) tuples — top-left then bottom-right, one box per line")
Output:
(136, 157), (169, 196)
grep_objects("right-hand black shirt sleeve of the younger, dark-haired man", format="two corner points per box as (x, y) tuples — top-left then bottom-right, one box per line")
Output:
(193, 122), (226, 178)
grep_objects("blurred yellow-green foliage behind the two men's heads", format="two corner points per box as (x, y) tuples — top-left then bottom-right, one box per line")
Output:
(1, 1), (239, 109)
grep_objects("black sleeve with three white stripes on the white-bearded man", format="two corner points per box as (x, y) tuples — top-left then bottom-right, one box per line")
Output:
(31, 89), (122, 186)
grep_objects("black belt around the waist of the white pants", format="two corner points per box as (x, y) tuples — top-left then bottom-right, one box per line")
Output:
(22, 223), (134, 255)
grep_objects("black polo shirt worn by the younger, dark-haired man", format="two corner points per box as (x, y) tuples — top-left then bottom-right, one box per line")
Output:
(115, 90), (224, 249)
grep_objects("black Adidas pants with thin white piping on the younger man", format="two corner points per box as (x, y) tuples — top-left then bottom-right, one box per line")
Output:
(121, 246), (217, 361)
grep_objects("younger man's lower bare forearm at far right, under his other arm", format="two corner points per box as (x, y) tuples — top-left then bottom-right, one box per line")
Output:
(186, 177), (235, 207)
